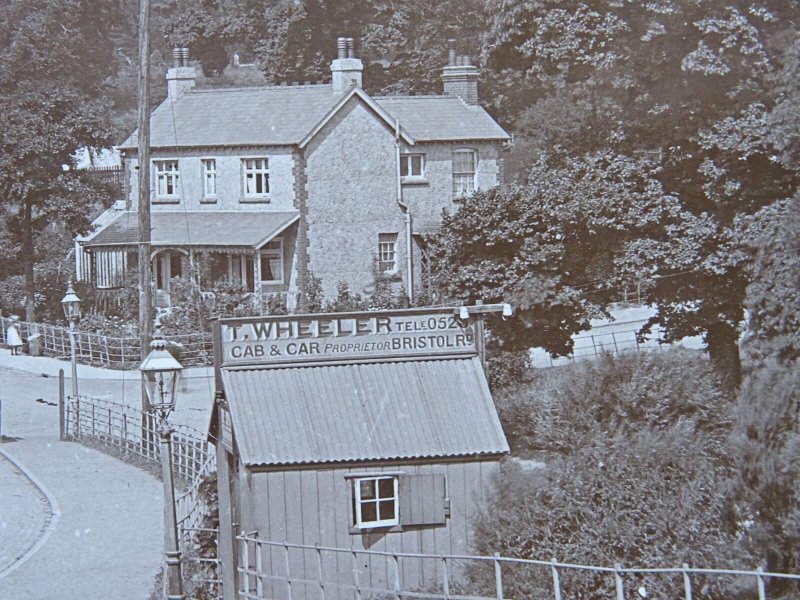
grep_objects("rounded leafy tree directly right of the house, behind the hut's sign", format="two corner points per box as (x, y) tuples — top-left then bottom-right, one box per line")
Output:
(430, 153), (685, 355)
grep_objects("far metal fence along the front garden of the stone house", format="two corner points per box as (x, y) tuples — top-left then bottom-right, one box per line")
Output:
(0, 317), (214, 369)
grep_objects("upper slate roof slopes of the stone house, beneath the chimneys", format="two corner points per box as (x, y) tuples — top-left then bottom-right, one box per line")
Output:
(120, 84), (509, 149)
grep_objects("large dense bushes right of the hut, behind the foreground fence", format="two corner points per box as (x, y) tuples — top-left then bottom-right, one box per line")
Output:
(475, 351), (758, 599)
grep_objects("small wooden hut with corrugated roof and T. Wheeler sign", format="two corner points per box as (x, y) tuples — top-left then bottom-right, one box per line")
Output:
(210, 309), (508, 600)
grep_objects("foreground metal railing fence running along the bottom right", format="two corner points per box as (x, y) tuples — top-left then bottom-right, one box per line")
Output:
(237, 532), (800, 600)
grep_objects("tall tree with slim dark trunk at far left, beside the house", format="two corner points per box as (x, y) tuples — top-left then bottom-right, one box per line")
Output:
(0, 0), (122, 320)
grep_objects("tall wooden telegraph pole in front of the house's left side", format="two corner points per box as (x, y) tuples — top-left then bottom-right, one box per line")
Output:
(137, 0), (154, 440)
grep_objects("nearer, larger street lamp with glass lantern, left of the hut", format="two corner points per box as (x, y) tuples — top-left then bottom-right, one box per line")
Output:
(139, 330), (183, 599)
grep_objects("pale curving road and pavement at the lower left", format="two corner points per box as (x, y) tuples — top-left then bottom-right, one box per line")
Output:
(0, 349), (206, 600)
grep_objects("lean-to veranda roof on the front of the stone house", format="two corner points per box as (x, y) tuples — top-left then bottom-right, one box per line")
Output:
(83, 211), (299, 248)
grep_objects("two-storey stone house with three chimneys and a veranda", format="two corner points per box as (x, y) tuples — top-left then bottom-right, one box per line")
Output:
(79, 38), (509, 312)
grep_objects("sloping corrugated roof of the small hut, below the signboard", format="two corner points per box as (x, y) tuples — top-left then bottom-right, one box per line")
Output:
(222, 357), (508, 466)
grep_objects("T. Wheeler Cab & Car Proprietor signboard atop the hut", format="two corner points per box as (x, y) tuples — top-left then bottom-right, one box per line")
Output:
(220, 311), (476, 365)
